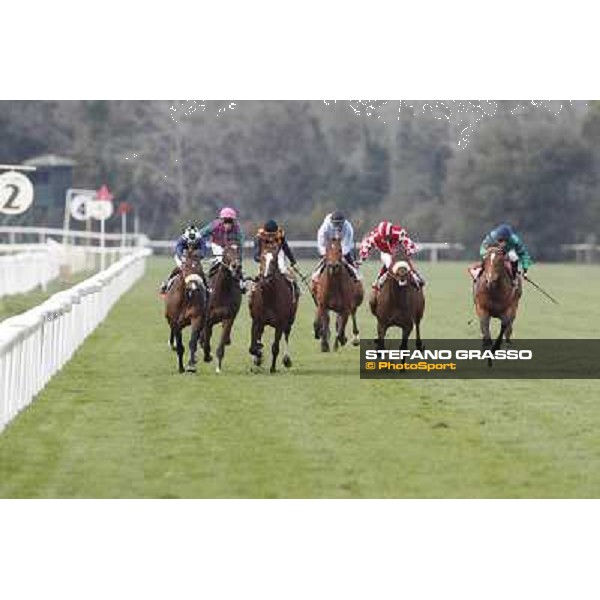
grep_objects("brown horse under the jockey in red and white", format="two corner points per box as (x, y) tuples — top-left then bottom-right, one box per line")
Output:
(370, 260), (425, 350)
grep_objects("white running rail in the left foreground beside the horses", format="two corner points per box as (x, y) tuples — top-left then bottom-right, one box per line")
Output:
(0, 249), (151, 431)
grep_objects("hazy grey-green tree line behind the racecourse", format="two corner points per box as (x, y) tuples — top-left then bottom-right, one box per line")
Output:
(0, 101), (600, 260)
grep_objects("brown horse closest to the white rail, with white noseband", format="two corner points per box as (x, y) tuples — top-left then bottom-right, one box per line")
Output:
(165, 252), (206, 373)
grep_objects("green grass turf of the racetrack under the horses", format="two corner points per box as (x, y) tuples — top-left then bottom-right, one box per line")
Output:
(0, 258), (600, 498)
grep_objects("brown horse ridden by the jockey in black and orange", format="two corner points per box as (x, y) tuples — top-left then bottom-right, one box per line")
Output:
(249, 245), (298, 373)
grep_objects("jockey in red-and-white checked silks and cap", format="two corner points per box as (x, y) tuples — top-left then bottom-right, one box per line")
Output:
(359, 221), (425, 291)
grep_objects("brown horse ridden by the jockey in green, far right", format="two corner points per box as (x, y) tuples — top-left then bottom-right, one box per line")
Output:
(473, 246), (521, 350)
